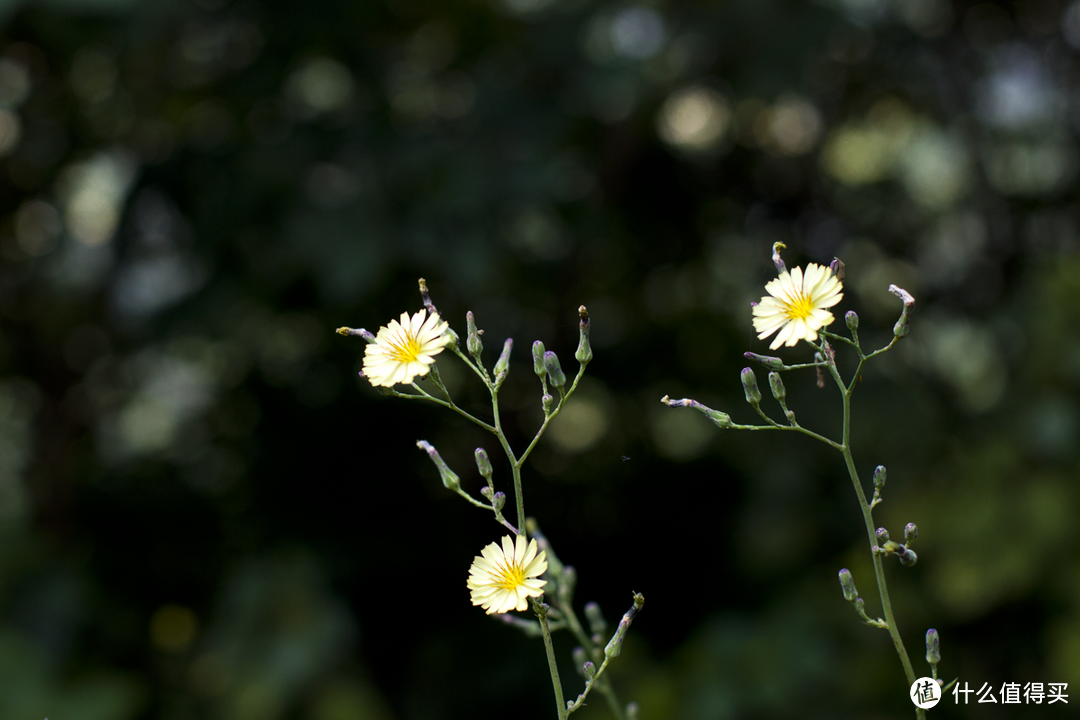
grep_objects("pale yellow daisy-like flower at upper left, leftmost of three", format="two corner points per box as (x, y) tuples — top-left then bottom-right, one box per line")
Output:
(364, 308), (450, 388)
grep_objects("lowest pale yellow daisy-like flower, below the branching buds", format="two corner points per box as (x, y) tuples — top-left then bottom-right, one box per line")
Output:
(469, 535), (548, 615)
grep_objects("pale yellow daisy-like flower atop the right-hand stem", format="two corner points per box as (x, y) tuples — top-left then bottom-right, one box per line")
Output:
(754, 262), (843, 350)
